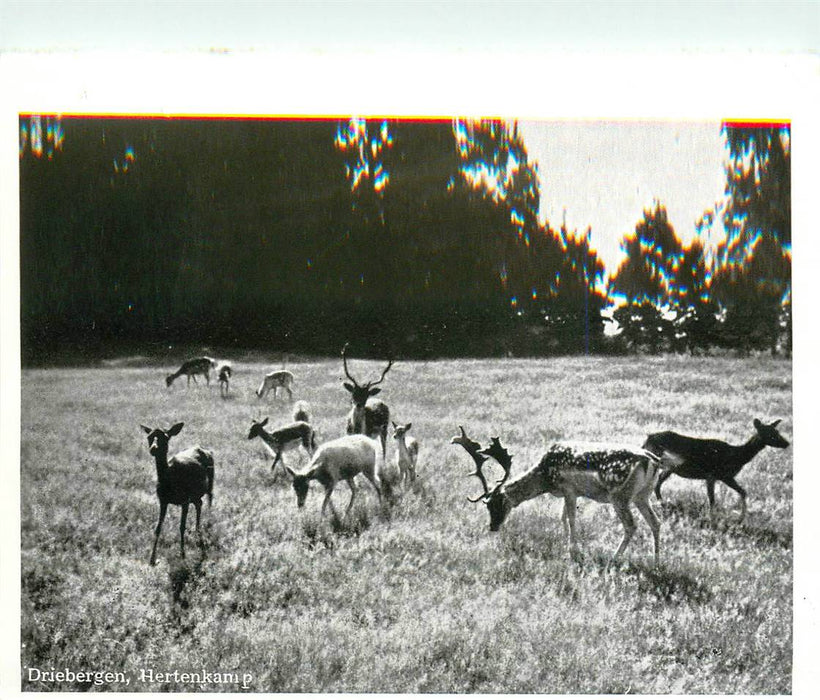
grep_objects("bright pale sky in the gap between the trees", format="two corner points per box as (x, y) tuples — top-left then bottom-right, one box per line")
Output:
(519, 121), (726, 274)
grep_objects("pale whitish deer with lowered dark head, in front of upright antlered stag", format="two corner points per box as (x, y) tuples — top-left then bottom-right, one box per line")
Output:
(285, 435), (384, 518)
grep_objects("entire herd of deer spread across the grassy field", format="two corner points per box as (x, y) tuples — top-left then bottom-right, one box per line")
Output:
(146, 346), (789, 566)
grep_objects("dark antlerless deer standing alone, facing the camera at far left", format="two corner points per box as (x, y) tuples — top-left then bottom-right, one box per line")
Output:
(140, 423), (214, 566)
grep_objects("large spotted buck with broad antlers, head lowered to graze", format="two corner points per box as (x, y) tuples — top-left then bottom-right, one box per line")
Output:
(450, 426), (660, 567)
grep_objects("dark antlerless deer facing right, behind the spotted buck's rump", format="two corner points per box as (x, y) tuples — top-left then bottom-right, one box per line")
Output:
(643, 418), (789, 522)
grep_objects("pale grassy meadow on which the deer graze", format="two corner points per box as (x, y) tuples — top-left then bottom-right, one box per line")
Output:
(21, 356), (793, 694)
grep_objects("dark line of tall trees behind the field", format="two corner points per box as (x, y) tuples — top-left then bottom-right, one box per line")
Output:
(20, 116), (791, 363)
